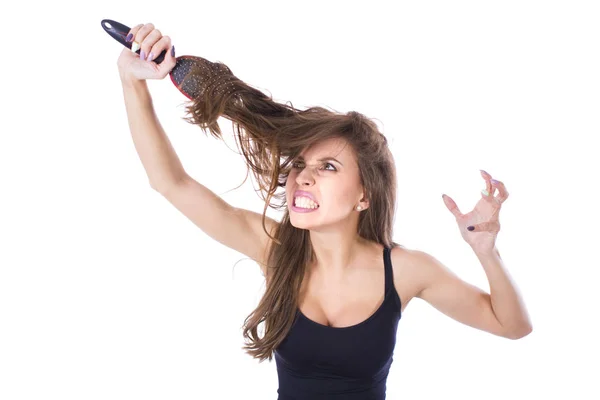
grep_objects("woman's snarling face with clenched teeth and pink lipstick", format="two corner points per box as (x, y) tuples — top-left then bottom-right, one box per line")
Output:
(286, 138), (368, 230)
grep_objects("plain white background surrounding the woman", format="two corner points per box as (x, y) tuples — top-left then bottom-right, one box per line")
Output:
(0, 0), (600, 400)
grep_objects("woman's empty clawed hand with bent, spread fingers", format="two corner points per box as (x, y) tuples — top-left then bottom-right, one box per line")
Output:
(443, 171), (508, 253)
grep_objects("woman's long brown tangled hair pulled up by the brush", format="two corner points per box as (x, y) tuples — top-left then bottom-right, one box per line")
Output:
(179, 59), (400, 362)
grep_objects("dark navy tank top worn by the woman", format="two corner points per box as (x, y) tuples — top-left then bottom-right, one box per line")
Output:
(274, 247), (401, 400)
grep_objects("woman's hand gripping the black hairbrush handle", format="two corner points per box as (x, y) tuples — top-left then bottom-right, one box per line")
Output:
(117, 24), (176, 80)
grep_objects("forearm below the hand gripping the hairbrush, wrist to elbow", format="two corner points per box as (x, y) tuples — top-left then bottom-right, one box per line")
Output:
(121, 76), (185, 190)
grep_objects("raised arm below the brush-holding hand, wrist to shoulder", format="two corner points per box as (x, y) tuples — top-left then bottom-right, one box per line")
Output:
(122, 77), (277, 275)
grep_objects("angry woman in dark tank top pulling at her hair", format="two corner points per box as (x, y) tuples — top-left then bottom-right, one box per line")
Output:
(118, 24), (532, 399)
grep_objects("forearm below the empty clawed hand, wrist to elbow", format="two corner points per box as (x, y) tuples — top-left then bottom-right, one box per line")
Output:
(476, 248), (532, 337)
